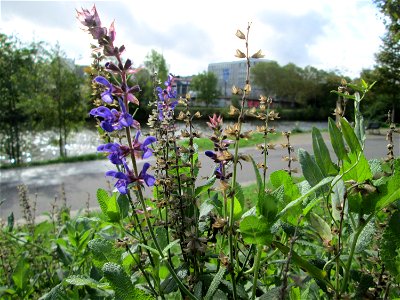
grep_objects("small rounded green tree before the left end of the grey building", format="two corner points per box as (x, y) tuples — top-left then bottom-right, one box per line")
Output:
(190, 71), (220, 105)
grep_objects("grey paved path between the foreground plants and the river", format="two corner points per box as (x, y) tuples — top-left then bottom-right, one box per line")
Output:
(0, 132), (400, 219)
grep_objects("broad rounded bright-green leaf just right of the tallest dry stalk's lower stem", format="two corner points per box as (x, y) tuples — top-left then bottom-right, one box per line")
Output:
(239, 216), (272, 245)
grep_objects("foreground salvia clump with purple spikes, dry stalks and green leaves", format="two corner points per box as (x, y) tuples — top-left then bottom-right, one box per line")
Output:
(56, 7), (400, 300)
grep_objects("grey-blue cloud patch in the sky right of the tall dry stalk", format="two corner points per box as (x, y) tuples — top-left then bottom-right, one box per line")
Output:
(259, 11), (329, 66)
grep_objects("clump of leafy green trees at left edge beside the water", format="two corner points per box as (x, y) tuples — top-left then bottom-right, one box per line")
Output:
(0, 35), (87, 164)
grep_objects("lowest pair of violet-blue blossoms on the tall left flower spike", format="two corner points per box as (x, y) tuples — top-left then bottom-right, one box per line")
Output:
(106, 161), (156, 195)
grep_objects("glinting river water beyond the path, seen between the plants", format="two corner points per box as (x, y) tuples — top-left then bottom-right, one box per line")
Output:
(0, 121), (327, 164)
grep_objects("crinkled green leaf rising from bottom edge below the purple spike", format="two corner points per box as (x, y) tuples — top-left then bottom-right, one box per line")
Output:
(102, 263), (155, 300)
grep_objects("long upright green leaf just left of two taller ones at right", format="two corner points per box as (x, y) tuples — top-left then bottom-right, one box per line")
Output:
(312, 127), (338, 176)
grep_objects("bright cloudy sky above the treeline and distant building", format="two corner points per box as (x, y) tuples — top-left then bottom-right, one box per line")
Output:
(0, 0), (385, 78)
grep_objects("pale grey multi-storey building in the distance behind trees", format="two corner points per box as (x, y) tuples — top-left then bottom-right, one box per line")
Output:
(208, 58), (268, 106)
